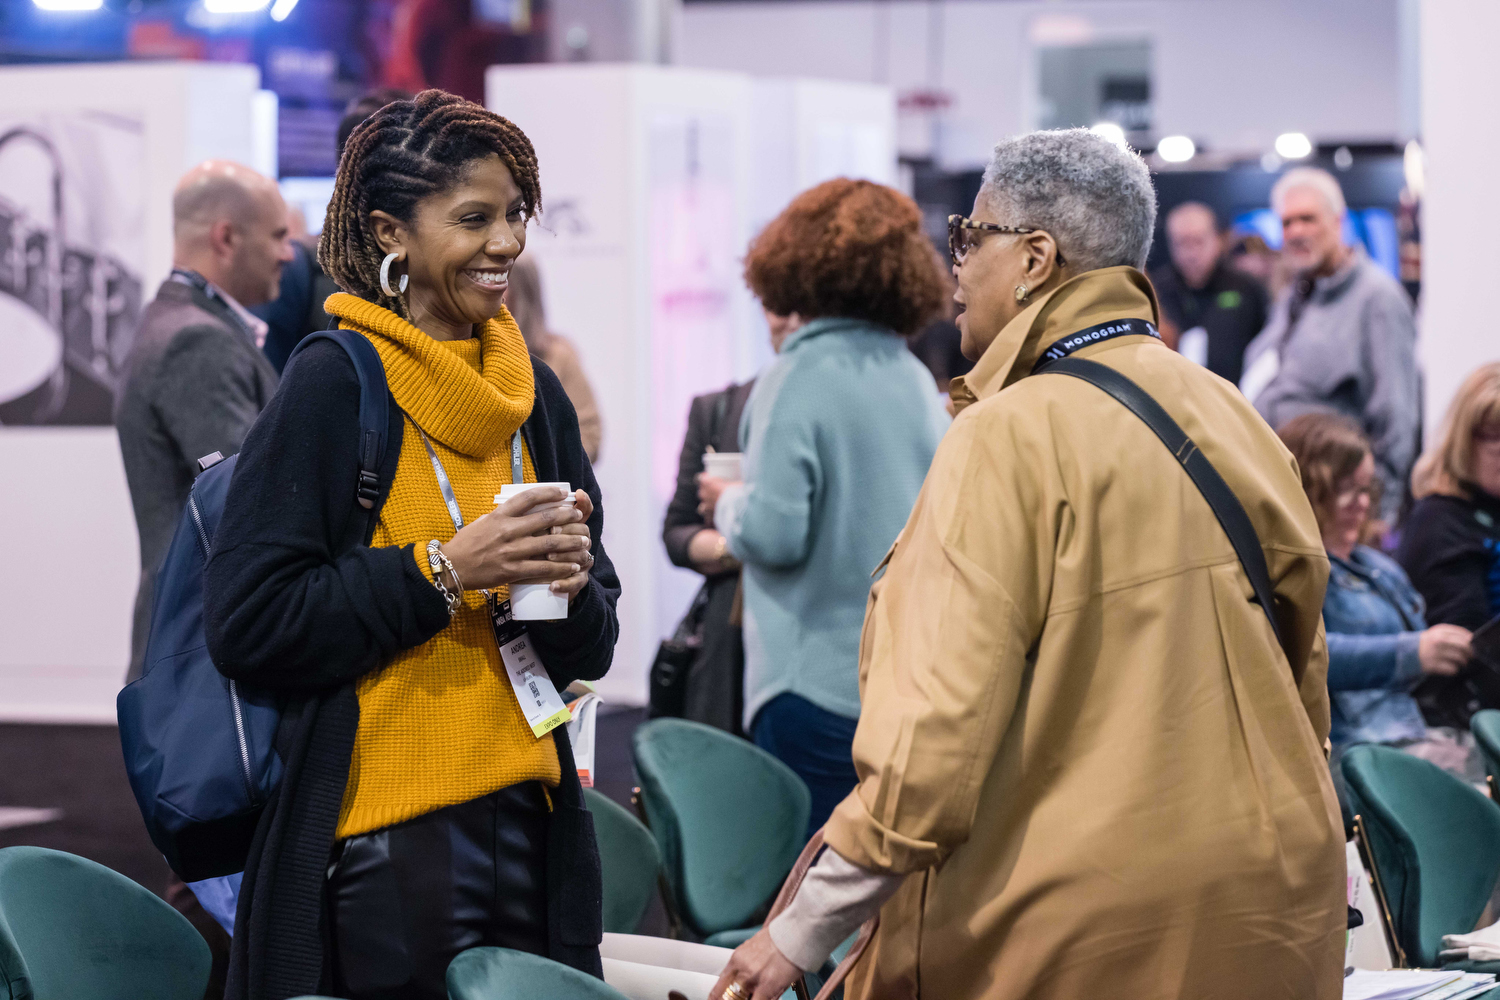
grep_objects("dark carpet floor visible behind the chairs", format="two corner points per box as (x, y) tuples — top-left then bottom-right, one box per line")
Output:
(0, 706), (666, 936)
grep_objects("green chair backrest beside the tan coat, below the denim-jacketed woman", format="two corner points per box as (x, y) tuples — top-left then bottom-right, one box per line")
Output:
(1343, 745), (1500, 967)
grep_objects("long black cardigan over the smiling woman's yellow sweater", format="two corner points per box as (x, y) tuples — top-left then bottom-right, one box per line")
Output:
(204, 342), (620, 1000)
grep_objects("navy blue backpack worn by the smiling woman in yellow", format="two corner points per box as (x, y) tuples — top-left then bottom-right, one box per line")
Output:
(116, 330), (390, 924)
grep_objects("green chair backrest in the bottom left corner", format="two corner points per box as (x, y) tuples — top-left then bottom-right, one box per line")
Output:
(0, 847), (212, 1000)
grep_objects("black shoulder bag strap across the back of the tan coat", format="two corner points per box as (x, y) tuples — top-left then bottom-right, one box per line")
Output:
(1037, 357), (1290, 660)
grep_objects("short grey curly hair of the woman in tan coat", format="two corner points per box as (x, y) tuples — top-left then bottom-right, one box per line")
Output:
(980, 129), (1157, 271)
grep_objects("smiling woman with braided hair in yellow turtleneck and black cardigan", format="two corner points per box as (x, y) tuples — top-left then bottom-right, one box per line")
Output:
(204, 90), (620, 1000)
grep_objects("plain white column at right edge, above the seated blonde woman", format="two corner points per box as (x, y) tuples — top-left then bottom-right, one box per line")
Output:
(1419, 0), (1500, 442)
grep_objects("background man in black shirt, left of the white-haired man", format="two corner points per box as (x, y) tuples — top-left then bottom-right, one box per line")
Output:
(1151, 201), (1266, 385)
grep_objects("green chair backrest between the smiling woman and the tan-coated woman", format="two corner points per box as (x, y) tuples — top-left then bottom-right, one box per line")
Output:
(633, 718), (812, 937)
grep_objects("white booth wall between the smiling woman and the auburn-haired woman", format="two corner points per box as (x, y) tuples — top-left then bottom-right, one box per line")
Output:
(486, 64), (896, 705)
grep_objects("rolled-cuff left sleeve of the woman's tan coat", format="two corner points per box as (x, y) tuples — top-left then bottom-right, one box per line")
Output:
(825, 411), (1067, 874)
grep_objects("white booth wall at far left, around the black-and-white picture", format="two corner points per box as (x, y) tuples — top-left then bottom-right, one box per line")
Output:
(0, 63), (260, 721)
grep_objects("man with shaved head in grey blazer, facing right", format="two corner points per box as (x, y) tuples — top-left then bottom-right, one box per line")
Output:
(116, 160), (293, 679)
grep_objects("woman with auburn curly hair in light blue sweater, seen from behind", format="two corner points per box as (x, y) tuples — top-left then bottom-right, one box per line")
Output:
(701, 178), (948, 834)
